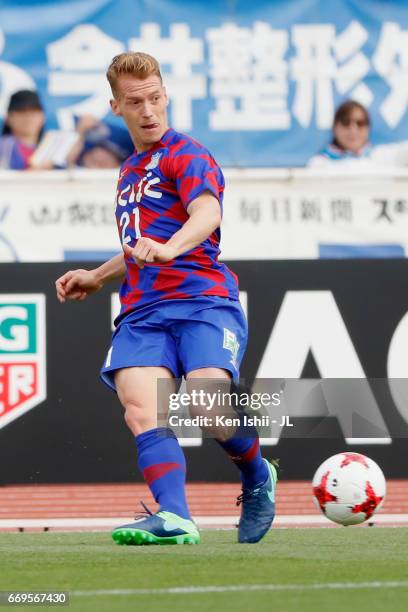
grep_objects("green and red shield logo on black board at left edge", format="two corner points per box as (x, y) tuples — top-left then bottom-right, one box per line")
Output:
(0, 293), (46, 428)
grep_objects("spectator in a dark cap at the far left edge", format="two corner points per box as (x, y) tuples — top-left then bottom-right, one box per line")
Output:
(0, 89), (52, 170)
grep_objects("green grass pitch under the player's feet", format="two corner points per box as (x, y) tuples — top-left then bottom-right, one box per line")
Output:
(0, 527), (408, 612)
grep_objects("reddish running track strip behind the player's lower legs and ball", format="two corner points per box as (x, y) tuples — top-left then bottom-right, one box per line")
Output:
(0, 480), (408, 520)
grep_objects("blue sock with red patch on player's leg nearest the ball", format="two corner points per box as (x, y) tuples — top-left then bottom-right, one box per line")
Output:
(217, 421), (269, 489)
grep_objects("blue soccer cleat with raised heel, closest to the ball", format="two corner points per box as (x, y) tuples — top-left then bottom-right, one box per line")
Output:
(237, 459), (278, 544)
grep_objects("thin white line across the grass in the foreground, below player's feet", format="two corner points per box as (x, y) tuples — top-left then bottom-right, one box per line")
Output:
(70, 581), (408, 597)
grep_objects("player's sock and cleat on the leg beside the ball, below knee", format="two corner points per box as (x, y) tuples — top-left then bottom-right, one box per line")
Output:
(218, 424), (278, 544)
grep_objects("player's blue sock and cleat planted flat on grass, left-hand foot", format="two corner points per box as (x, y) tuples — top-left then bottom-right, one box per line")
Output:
(112, 428), (200, 545)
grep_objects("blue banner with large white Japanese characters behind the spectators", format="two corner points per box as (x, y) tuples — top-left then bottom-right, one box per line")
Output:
(0, 0), (408, 166)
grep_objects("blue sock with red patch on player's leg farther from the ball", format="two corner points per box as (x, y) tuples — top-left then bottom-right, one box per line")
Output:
(135, 427), (191, 519)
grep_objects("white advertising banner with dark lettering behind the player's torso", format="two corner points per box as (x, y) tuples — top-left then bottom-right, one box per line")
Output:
(0, 169), (408, 262)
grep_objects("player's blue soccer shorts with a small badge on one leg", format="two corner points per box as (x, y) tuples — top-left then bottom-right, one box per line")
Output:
(100, 296), (248, 390)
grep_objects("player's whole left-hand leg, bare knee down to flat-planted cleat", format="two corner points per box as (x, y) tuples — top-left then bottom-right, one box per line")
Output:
(112, 367), (200, 544)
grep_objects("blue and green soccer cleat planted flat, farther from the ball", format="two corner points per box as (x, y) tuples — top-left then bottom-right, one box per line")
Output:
(112, 510), (200, 546)
